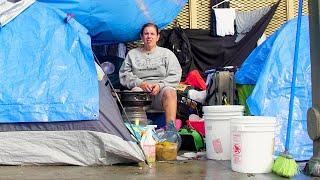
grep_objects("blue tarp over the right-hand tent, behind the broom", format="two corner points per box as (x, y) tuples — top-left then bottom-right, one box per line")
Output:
(236, 16), (313, 160)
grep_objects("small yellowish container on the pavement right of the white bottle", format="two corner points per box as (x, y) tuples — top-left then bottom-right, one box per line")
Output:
(156, 141), (178, 161)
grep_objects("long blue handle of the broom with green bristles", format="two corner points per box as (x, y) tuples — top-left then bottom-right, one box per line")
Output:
(285, 0), (303, 152)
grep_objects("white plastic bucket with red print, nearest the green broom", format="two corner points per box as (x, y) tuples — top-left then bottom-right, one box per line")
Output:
(230, 116), (276, 173)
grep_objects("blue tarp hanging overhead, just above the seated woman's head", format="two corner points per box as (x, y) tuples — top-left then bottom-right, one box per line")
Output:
(38, 0), (187, 44)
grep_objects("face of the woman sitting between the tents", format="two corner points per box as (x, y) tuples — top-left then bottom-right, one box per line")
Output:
(141, 26), (160, 50)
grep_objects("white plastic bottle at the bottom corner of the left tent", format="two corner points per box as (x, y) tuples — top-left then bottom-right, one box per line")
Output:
(141, 125), (157, 163)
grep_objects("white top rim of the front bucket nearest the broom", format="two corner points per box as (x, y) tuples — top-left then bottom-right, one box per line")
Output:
(231, 116), (276, 124)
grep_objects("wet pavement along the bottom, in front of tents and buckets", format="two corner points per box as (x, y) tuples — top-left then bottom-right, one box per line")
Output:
(0, 160), (314, 180)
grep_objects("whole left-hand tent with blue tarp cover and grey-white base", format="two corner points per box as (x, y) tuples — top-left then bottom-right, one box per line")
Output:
(0, 2), (144, 166)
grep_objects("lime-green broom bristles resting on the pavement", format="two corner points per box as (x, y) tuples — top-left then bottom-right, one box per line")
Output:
(272, 155), (299, 177)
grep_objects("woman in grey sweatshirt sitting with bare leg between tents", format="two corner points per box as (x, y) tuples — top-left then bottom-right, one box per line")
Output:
(119, 23), (182, 125)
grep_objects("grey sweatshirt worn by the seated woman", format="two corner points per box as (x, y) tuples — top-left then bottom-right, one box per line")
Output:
(119, 46), (182, 89)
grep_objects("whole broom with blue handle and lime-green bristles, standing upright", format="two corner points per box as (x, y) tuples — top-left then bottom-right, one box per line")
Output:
(272, 0), (303, 177)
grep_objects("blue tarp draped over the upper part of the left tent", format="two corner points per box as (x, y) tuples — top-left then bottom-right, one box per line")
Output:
(0, 2), (99, 123)
